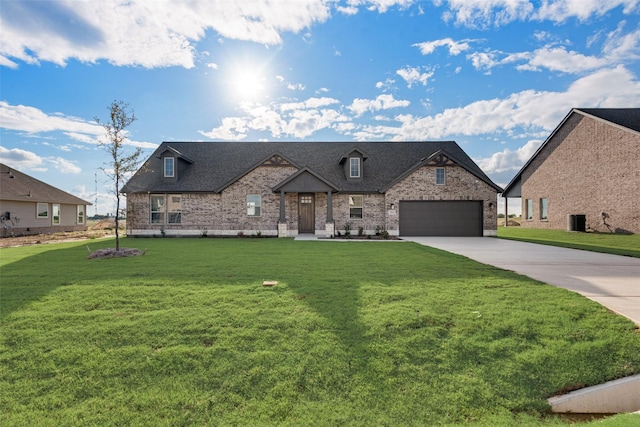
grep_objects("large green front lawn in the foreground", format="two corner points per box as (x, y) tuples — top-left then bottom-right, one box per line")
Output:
(0, 239), (640, 426)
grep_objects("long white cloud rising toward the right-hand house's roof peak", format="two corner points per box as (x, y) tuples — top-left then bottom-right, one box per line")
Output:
(356, 66), (640, 140)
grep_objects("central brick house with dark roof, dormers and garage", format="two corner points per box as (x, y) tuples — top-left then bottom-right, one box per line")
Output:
(122, 141), (502, 237)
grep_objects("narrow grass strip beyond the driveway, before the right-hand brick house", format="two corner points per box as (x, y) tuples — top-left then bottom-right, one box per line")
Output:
(498, 227), (640, 258)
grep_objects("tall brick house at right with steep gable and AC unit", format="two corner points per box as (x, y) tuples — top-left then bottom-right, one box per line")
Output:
(503, 108), (640, 233)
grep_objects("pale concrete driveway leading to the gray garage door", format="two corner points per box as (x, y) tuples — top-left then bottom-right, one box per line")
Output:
(402, 237), (640, 325)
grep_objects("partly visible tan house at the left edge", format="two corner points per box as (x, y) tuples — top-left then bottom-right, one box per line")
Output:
(0, 163), (91, 237)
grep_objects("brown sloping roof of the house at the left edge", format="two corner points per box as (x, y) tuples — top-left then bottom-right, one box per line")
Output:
(0, 163), (91, 205)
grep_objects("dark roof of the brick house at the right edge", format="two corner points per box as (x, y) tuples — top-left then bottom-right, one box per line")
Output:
(502, 108), (640, 197)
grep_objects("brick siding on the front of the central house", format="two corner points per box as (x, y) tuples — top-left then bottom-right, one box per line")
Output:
(127, 166), (497, 236)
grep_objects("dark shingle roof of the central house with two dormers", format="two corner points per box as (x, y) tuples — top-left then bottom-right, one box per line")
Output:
(122, 141), (502, 193)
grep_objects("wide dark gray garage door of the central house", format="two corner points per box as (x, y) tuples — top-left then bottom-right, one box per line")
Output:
(400, 200), (482, 236)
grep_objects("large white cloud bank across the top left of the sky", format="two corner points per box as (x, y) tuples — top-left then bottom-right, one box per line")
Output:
(0, 0), (330, 68)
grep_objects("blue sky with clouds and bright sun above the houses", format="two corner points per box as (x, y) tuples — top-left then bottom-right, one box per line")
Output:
(0, 0), (640, 214)
